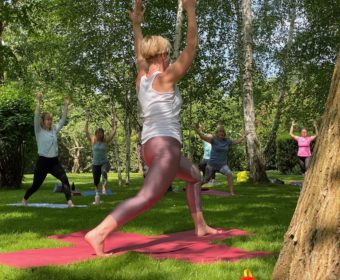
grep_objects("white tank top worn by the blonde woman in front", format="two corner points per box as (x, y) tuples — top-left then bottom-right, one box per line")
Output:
(138, 71), (182, 144)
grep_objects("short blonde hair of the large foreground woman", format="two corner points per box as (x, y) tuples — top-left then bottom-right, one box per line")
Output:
(141, 36), (171, 61)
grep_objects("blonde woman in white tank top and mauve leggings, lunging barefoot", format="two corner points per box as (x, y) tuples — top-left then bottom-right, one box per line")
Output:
(85, 0), (220, 256)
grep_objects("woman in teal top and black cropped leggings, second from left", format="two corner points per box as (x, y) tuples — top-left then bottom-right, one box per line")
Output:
(84, 116), (117, 194)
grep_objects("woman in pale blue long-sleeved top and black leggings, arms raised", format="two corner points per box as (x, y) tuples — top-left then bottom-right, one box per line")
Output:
(22, 92), (74, 207)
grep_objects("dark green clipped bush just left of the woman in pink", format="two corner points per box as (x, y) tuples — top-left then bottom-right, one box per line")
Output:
(276, 134), (298, 174)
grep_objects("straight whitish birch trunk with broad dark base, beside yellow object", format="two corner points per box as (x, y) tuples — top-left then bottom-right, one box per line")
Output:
(241, 0), (268, 182)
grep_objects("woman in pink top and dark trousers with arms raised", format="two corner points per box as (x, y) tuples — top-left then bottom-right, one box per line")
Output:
(289, 121), (318, 174)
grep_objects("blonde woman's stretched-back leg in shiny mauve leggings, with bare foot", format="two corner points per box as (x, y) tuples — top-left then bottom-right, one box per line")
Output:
(85, 137), (181, 256)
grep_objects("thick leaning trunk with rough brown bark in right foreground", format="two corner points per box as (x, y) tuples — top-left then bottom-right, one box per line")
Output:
(273, 52), (340, 280)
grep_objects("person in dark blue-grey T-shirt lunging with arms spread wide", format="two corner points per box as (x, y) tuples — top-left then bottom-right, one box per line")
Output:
(193, 124), (245, 195)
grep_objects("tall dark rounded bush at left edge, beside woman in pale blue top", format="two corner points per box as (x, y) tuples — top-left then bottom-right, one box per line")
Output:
(0, 85), (34, 188)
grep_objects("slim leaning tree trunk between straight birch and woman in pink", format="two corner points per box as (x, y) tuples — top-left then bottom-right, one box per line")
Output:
(264, 0), (296, 162)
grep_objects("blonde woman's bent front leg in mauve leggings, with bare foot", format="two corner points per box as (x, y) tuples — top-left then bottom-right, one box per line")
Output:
(176, 156), (221, 236)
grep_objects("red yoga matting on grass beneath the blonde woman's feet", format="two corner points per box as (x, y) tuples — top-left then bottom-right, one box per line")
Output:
(0, 229), (270, 268)
